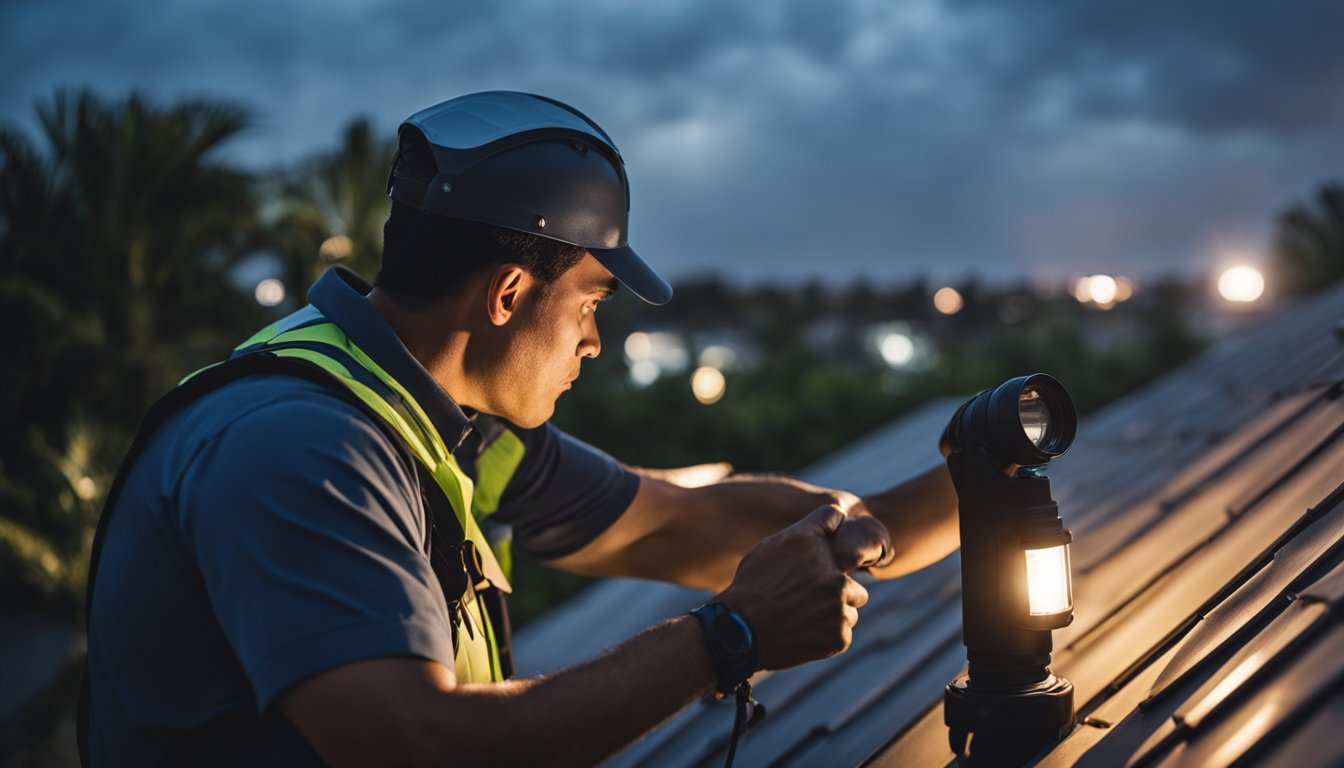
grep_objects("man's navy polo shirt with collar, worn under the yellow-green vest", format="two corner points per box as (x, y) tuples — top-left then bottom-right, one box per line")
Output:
(89, 270), (638, 765)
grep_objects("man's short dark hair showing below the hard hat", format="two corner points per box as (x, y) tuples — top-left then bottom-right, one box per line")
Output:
(374, 202), (586, 309)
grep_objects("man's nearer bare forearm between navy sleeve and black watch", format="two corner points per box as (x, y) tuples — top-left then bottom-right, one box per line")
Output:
(286, 615), (714, 767)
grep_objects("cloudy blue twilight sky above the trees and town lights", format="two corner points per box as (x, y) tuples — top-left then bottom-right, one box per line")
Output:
(0, 0), (1344, 281)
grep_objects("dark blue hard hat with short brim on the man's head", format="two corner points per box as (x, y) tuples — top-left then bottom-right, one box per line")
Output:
(387, 90), (672, 304)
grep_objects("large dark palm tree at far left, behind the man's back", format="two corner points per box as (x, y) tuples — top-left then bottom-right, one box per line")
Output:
(0, 90), (258, 618)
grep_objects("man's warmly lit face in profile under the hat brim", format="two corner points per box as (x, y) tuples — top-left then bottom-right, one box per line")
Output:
(487, 254), (617, 428)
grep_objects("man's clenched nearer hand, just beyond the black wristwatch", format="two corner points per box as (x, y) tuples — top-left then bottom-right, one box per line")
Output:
(719, 506), (891, 670)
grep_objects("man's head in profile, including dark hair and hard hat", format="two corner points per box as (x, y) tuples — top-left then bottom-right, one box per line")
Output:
(375, 91), (672, 426)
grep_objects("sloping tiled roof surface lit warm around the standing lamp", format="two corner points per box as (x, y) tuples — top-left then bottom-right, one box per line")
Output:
(517, 288), (1344, 765)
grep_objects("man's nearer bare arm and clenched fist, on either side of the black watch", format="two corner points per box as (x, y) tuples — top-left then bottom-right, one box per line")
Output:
(278, 507), (887, 765)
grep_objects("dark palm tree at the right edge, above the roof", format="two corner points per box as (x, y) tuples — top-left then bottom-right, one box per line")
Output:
(1274, 183), (1344, 293)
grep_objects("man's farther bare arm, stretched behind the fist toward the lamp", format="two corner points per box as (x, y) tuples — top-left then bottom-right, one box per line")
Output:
(550, 464), (960, 589)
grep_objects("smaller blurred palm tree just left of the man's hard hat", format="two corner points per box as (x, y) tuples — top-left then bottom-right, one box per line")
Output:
(267, 118), (396, 302)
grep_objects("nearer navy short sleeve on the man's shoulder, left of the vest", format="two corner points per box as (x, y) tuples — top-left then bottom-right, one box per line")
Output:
(177, 387), (453, 712)
